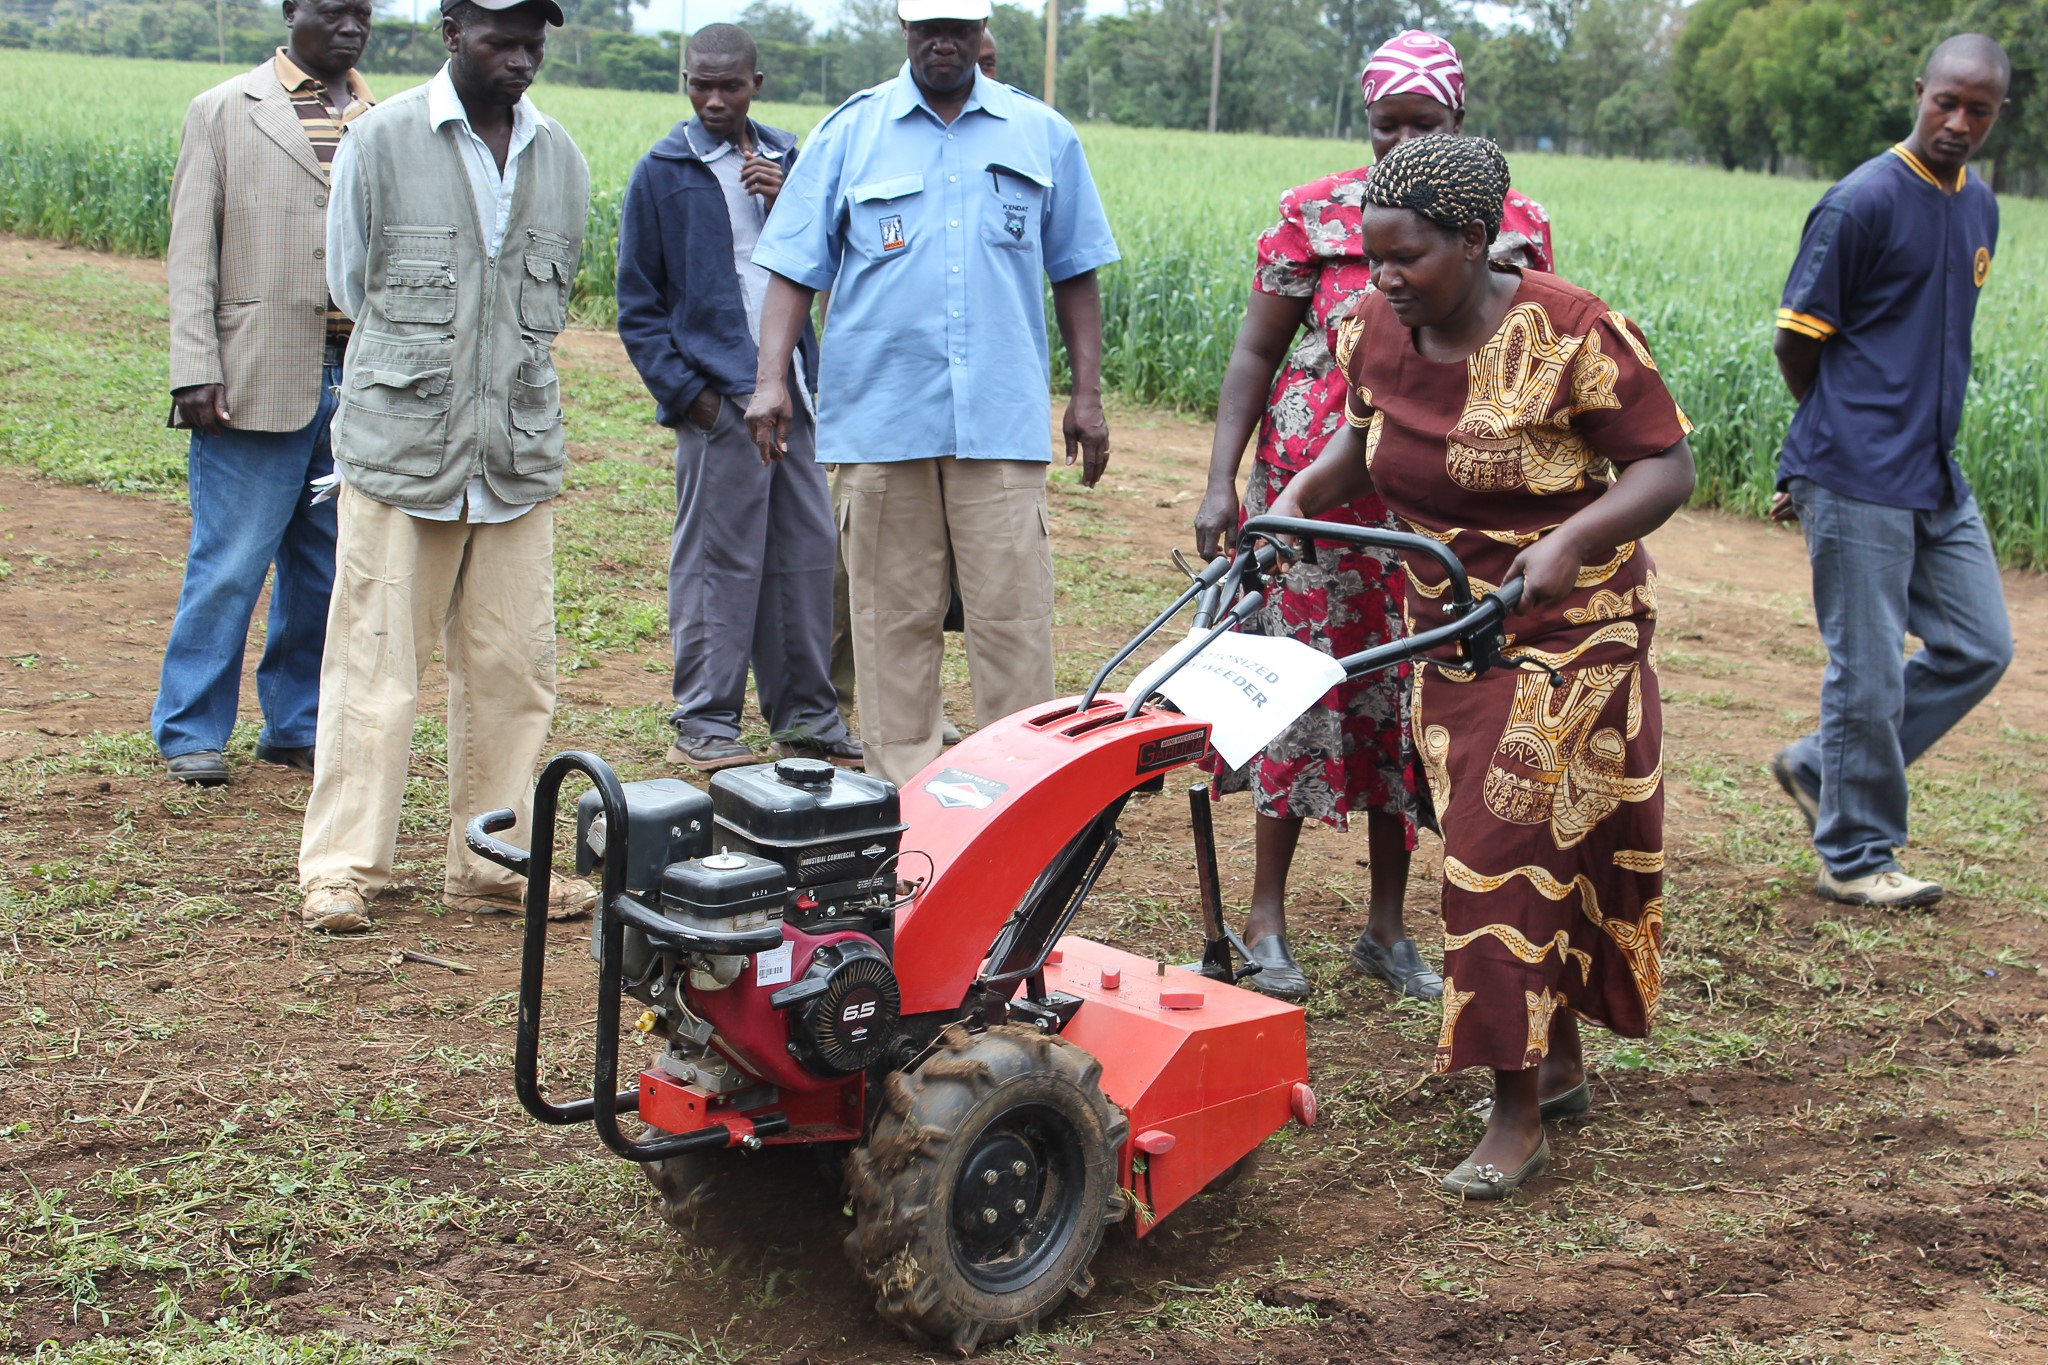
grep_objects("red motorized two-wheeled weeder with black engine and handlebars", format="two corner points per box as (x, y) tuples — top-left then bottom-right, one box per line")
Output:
(469, 518), (1520, 1355)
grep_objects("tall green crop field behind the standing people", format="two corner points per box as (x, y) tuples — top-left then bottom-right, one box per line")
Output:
(0, 51), (2048, 567)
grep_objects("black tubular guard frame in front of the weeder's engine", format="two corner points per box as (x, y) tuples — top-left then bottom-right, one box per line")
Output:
(465, 749), (788, 1162)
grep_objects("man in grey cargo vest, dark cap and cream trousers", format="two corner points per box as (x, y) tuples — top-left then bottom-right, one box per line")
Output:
(299, 0), (596, 933)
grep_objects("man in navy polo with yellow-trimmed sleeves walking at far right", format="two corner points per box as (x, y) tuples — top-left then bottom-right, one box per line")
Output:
(1772, 33), (2013, 907)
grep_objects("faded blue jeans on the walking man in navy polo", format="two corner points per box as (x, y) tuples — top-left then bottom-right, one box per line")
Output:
(1788, 479), (2013, 880)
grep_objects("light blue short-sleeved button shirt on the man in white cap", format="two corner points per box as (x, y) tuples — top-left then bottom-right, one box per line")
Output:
(754, 61), (1118, 465)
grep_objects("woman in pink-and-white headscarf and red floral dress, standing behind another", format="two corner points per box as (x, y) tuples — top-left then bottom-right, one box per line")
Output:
(1194, 29), (1554, 1001)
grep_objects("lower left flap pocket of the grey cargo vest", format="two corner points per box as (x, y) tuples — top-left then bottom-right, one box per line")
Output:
(334, 332), (455, 477)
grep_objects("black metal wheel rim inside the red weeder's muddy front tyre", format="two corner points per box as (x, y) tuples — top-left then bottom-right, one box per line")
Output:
(952, 1105), (1083, 1293)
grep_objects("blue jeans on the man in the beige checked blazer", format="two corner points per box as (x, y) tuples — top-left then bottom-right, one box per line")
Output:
(150, 366), (342, 759)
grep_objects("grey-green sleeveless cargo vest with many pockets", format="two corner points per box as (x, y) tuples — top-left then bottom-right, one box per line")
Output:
(334, 86), (590, 510)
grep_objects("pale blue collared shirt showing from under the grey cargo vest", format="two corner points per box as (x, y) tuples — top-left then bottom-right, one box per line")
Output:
(328, 63), (541, 524)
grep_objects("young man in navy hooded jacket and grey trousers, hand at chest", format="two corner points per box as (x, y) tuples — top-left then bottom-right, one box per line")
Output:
(618, 25), (860, 772)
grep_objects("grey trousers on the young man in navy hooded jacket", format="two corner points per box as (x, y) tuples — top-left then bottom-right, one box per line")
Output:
(668, 397), (846, 743)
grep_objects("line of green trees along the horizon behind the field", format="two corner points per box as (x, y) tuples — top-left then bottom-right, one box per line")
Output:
(0, 0), (2048, 192)
